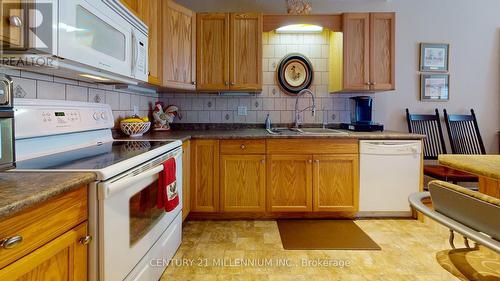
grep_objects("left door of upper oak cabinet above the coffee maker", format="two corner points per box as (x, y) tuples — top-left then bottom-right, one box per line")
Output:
(343, 14), (370, 91)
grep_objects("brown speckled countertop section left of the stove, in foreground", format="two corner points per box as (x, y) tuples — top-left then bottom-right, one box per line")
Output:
(0, 172), (96, 219)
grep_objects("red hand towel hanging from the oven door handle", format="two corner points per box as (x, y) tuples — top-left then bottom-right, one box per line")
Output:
(156, 158), (179, 212)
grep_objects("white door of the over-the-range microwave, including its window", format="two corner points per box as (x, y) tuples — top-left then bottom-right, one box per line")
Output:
(59, 0), (133, 77)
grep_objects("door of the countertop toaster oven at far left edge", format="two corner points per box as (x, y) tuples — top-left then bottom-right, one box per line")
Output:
(0, 110), (15, 171)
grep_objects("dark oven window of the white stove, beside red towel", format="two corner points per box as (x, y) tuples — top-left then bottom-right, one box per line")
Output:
(129, 178), (165, 246)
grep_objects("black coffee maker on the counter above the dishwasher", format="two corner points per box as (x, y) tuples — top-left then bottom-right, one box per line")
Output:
(341, 96), (384, 132)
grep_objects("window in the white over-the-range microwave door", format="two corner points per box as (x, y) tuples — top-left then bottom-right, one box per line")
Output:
(75, 6), (125, 61)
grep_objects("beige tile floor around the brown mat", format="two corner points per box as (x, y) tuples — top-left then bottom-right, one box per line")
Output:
(162, 220), (459, 281)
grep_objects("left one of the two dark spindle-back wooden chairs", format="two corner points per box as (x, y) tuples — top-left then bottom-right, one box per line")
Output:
(406, 108), (479, 184)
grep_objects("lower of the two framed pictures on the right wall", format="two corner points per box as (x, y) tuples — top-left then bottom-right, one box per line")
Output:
(420, 74), (450, 101)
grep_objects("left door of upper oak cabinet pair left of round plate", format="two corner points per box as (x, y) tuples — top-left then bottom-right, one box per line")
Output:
(196, 13), (229, 91)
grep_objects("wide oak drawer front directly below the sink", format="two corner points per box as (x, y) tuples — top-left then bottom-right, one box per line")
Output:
(267, 139), (359, 155)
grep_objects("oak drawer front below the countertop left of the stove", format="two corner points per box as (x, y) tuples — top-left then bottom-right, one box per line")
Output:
(0, 187), (88, 268)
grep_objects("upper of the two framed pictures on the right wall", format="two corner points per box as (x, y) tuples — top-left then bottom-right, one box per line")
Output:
(420, 43), (450, 72)
